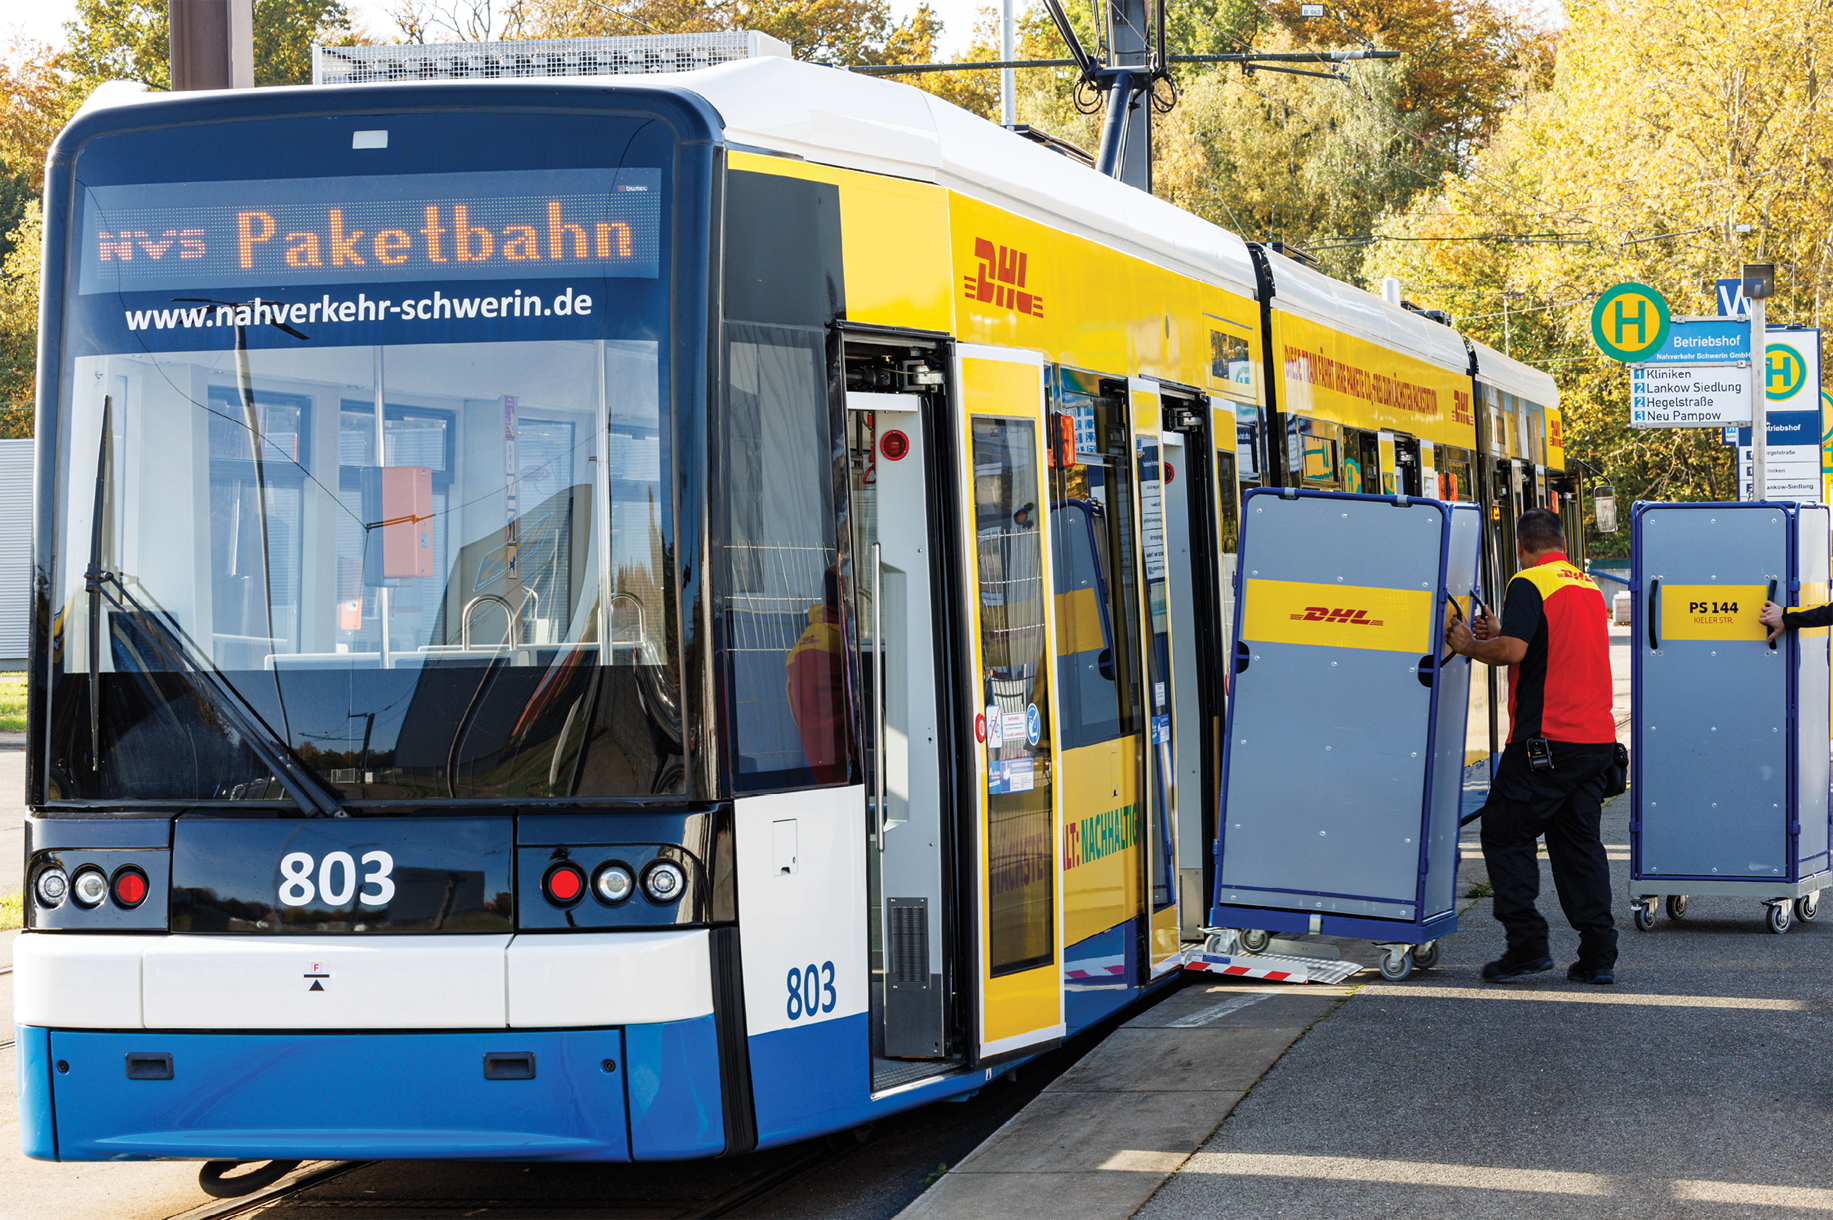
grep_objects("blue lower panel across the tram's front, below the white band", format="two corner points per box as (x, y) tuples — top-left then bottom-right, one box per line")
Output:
(18, 1017), (724, 1161)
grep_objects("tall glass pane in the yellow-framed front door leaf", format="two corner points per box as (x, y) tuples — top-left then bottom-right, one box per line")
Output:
(971, 418), (1056, 975)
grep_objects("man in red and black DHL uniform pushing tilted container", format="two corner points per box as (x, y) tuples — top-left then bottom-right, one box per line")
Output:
(1446, 507), (1617, 984)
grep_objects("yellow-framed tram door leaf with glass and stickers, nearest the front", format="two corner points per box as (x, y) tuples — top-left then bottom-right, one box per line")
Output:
(955, 344), (1065, 1061)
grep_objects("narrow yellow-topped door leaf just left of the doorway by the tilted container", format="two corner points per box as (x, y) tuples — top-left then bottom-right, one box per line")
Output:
(1127, 377), (1190, 973)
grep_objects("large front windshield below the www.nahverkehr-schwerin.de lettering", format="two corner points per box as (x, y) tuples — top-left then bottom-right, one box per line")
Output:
(51, 339), (689, 801)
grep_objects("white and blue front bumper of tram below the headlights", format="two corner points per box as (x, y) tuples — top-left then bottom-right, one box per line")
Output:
(15, 932), (726, 1161)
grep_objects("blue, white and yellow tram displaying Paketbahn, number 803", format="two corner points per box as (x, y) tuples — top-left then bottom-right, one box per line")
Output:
(15, 42), (1573, 1161)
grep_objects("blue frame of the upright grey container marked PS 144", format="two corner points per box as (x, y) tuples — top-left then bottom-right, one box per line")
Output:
(1630, 500), (1813, 898)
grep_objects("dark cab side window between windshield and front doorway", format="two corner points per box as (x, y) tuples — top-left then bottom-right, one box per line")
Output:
(719, 322), (852, 791)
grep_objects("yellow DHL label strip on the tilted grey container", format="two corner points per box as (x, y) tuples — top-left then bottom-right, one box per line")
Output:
(1241, 579), (1433, 654)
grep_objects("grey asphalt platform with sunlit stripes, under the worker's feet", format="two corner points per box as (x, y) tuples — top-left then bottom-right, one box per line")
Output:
(1138, 787), (1833, 1220)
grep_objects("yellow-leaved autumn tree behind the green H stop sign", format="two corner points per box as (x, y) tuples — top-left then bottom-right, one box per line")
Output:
(1369, 0), (1833, 553)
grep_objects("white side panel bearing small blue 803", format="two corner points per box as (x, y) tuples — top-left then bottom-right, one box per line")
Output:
(735, 788), (868, 1033)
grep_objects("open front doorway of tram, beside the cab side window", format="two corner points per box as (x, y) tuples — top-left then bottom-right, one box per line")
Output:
(845, 332), (960, 1092)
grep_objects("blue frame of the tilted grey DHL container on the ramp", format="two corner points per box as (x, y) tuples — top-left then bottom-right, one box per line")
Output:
(1210, 487), (1485, 945)
